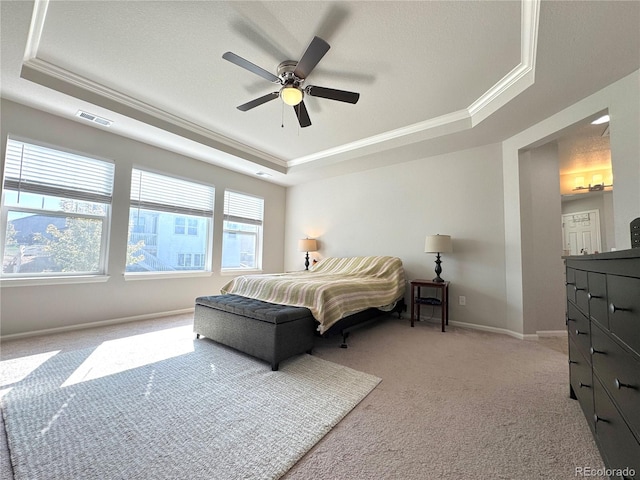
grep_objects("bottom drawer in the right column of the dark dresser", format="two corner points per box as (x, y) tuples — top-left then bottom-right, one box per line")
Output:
(594, 378), (640, 478)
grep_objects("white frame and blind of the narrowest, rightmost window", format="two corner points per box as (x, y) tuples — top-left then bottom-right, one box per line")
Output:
(220, 189), (264, 273)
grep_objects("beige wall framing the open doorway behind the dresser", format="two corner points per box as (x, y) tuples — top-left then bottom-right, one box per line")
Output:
(502, 71), (640, 333)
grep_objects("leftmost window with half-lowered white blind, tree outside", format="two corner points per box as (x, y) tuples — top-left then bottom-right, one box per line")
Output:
(1, 138), (114, 278)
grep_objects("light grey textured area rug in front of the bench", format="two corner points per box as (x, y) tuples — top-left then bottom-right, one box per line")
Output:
(2, 330), (380, 480)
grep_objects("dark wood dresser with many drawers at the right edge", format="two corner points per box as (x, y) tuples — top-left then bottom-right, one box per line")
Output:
(565, 248), (640, 479)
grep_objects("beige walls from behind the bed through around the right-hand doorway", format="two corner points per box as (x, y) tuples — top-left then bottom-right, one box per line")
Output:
(285, 71), (640, 335)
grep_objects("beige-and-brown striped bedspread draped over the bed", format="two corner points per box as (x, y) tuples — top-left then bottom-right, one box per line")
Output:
(221, 256), (405, 333)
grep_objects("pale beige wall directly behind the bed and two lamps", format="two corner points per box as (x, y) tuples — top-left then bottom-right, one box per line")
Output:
(285, 141), (506, 329)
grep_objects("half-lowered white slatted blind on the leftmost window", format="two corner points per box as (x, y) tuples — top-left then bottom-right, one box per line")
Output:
(4, 138), (115, 204)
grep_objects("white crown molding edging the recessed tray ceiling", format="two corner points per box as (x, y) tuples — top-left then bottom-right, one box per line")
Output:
(21, 0), (541, 173)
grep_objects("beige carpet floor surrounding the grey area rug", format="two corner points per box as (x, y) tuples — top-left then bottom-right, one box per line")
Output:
(0, 316), (602, 480)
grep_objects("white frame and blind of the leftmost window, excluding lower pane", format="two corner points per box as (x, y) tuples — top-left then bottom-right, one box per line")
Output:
(0, 136), (115, 286)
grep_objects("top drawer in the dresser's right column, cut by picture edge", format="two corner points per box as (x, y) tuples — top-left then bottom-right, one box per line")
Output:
(607, 275), (640, 354)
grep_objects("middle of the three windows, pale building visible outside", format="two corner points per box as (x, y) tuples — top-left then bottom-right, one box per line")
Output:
(126, 169), (215, 273)
